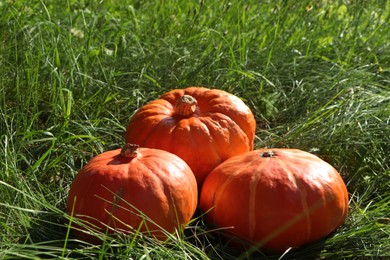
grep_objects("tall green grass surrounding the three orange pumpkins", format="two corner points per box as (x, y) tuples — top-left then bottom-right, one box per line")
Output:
(0, 0), (390, 259)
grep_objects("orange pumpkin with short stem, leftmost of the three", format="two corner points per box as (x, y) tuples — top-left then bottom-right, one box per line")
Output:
(67, 144), (198, 243)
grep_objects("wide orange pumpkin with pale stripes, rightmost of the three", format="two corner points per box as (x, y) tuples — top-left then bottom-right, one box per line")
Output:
(199, 149), (348, 252)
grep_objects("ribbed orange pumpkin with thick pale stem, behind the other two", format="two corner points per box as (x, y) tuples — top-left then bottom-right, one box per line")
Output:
(126, 87), (256, 186)
